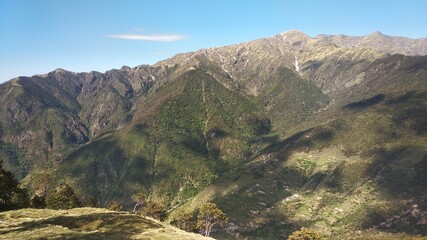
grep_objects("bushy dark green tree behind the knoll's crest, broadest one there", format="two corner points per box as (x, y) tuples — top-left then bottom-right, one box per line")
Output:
(46, 183), (81, 209)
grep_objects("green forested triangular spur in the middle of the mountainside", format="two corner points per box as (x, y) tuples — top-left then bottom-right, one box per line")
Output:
(59, 69), (270, 208)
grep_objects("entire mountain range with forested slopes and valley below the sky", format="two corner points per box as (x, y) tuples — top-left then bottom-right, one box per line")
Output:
(0, 31), (427, 239)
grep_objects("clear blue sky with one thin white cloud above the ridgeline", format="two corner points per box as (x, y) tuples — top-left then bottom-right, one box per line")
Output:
(0, 0), (427, 82)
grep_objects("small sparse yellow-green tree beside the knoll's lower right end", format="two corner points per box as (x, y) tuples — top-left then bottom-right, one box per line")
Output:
(197, 202), (228, 237)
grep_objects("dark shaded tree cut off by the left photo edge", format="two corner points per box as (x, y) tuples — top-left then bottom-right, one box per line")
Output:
(0, 160), (29, 211)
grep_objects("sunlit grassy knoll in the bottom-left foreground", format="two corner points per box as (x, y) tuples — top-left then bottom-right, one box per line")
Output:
(0, 208), (210, 240)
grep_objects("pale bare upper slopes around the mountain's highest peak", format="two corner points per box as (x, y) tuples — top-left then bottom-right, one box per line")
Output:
(155, 31), (427, 101)
